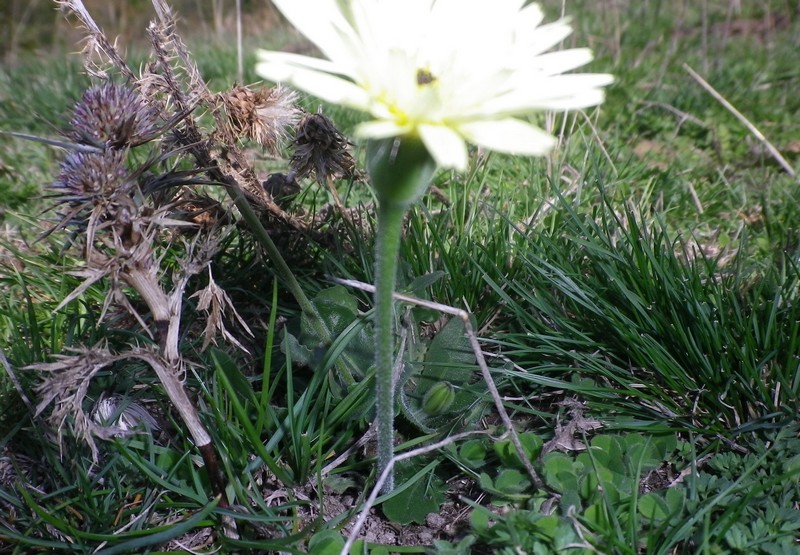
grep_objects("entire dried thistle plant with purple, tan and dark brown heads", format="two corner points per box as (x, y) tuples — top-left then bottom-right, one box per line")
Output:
(33, 0), (360, 535)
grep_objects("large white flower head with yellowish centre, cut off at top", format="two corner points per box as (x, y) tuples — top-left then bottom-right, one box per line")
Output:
(256, 0), (612, 170)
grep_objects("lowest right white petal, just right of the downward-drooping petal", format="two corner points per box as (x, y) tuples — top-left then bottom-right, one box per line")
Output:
(458, 118), (556, 156)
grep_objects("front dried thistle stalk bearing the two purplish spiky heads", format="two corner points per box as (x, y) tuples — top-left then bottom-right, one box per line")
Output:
(34, 77), (225, 482)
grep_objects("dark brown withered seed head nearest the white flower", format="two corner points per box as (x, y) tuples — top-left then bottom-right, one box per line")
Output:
(290, 114), (355, 183)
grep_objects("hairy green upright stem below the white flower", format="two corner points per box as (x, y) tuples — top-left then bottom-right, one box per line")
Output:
(374, 202), (408, 493)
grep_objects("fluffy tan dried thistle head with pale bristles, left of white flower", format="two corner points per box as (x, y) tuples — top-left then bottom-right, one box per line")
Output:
(221, 85), (298, 151)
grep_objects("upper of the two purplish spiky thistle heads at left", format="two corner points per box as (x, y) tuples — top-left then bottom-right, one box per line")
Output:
(67, 82), (158, 148)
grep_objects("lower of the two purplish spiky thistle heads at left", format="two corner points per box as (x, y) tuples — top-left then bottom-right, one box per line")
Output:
(52, 149), (130, 205)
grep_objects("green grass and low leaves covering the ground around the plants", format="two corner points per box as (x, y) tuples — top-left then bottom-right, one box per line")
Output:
(0, 0), (800, 554)
